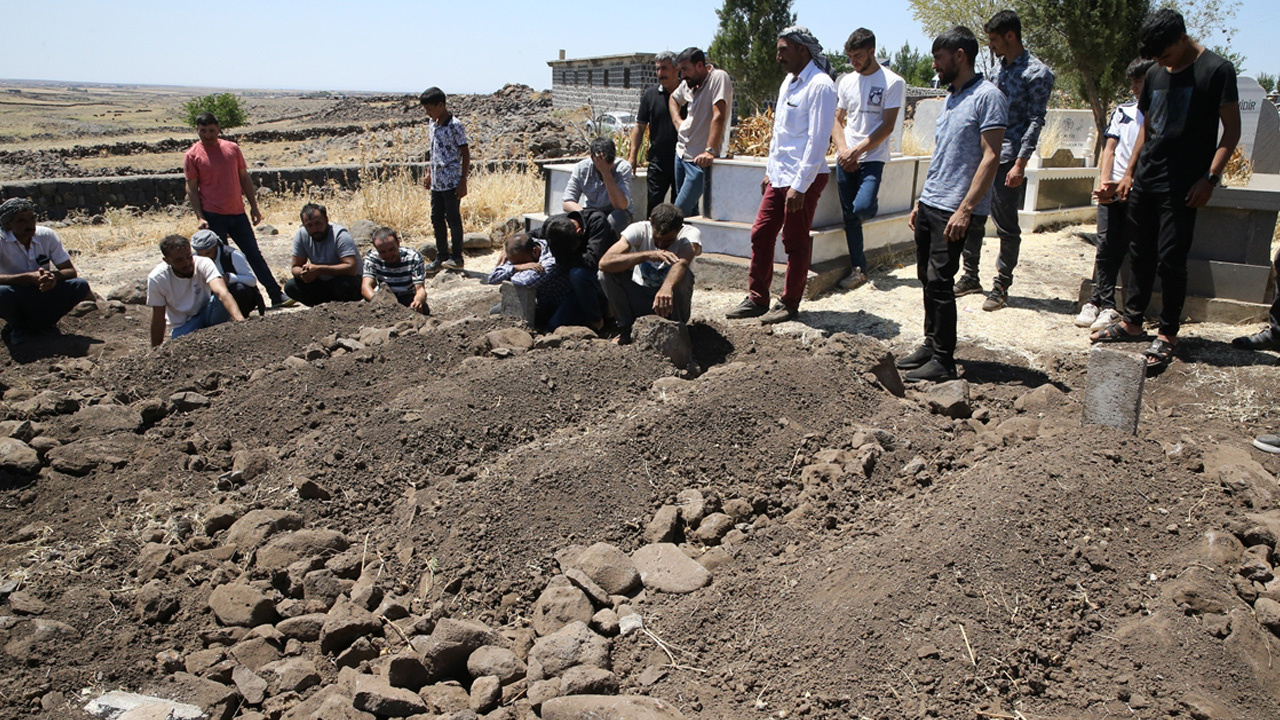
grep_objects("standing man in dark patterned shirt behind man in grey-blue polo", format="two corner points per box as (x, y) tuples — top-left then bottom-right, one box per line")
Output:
(955, 10), (1053, 311)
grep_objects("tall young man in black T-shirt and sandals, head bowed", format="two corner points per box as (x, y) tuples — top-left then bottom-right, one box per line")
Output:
(1091, 9), (1240, 372)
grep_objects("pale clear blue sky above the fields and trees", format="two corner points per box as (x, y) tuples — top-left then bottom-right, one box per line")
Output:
(0, 0), (1280, 94)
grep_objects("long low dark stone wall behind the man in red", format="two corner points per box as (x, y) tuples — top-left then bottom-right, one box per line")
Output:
(0, 160), (526, 220)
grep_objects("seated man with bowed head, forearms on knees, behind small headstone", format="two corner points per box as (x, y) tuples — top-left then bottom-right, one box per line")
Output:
(600, 202), (703, 345)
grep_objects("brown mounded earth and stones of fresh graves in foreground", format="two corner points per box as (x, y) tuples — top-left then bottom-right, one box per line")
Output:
(0, 298), (1280, 719)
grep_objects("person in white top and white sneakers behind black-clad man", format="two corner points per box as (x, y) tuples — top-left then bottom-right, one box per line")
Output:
(1075, 58), (1156, 331)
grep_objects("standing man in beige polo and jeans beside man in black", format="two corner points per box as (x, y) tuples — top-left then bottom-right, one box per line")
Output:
(667, 47), (733, 218)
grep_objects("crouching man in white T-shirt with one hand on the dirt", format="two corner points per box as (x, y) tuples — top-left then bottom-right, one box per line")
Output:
(147, 234), (244, 347)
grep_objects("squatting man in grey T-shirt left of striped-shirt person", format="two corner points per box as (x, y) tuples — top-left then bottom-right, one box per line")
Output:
(284, 202), (362, 306)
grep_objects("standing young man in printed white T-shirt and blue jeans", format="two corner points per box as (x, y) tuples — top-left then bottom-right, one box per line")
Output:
(831, 28), (906, 290)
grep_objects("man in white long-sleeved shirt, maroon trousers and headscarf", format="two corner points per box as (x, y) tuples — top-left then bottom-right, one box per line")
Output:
(726, 26), (836, 325)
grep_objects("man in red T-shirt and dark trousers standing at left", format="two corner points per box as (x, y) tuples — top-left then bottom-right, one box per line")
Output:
(182, 113), (291, 306)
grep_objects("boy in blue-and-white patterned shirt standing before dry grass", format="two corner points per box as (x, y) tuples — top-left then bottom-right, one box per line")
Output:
(419, 87), (471, 273)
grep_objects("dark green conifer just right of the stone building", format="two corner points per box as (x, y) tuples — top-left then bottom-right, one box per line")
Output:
(707, 0), (796, 111)
